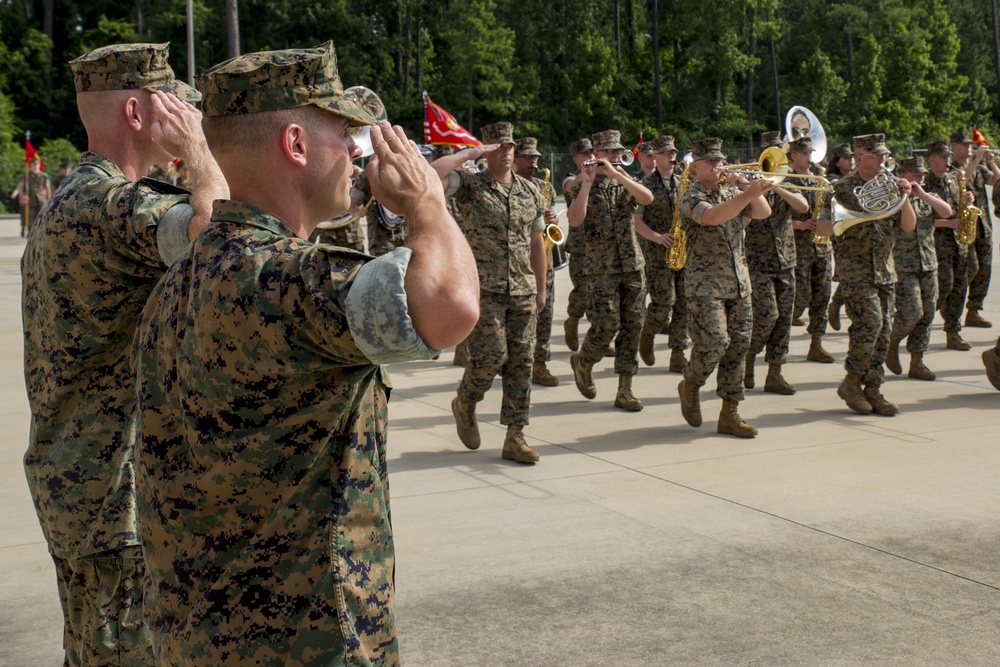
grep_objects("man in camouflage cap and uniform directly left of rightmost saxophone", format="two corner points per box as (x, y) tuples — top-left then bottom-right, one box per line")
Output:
(924, 140), (972, 350)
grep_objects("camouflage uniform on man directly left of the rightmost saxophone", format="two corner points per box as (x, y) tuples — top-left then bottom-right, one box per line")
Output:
(924, 171), (969, 333)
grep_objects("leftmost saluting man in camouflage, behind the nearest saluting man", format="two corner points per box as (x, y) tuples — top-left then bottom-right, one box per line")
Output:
(21, 44), (228, 665)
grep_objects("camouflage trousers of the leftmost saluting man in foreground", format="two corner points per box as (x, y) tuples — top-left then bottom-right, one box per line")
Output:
(52, 546), (154, 667)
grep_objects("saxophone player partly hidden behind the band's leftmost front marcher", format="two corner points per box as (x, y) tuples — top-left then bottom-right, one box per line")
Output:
(514, 137), (559, 387)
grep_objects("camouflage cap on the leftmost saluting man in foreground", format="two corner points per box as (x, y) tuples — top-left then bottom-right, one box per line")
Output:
(69, 43), (201, 103)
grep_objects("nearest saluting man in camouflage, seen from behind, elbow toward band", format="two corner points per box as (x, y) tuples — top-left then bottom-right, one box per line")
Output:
(133, 43), (476, 666)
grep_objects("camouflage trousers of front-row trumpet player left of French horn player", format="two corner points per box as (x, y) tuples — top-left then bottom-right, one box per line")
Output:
(684, 294), (753, 401)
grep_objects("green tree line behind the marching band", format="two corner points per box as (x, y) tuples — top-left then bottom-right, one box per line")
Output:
(0, 0), (1000, 211)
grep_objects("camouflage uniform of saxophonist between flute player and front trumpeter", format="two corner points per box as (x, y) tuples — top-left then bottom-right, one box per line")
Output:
(636, 166), (688, 351)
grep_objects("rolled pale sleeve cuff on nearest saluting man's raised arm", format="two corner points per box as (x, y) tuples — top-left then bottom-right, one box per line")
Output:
(344, 248), (439, 364)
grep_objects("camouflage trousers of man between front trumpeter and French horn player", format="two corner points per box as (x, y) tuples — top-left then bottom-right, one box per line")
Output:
(748, 269), (795, 364)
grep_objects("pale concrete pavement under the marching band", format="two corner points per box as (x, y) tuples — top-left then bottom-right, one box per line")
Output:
(0, 213), (1000, 667)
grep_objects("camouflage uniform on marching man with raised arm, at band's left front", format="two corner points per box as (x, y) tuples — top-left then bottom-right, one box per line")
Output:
(446, 165), (545, 426)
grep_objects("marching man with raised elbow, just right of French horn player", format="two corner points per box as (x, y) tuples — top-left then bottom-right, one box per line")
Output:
(885, 156), (952, 380)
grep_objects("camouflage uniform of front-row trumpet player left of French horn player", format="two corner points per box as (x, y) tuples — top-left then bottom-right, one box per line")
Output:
(679, 178), (753, 401)
